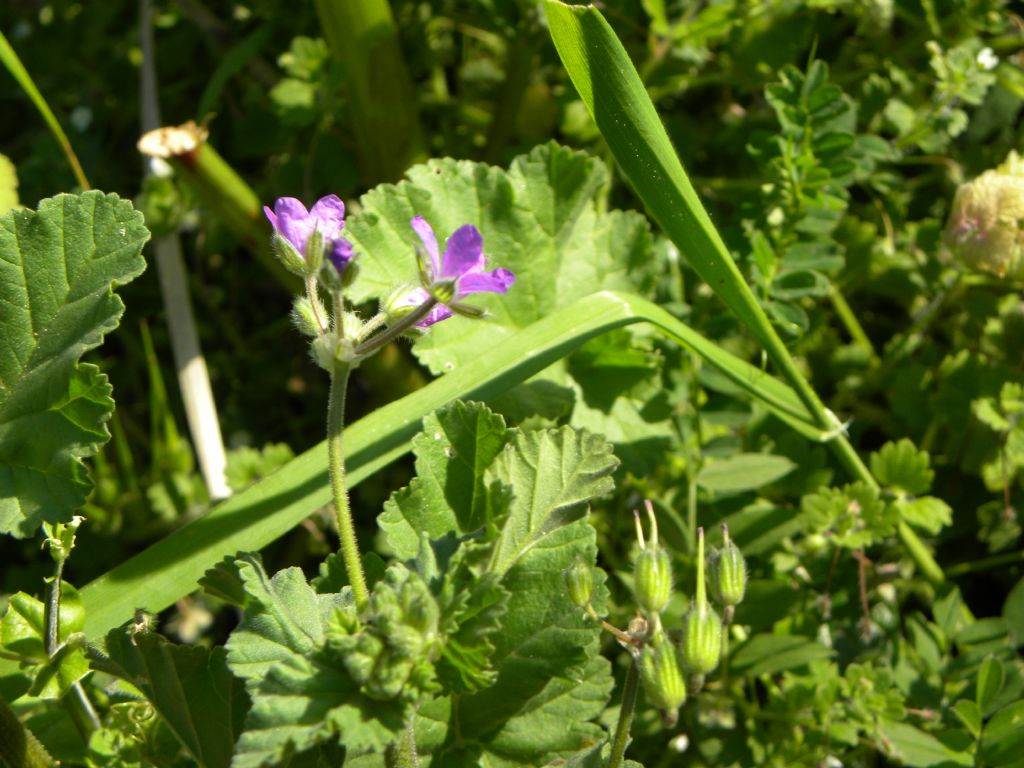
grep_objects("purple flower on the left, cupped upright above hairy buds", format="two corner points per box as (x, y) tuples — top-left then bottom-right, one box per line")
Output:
(263, 195), (352, 272)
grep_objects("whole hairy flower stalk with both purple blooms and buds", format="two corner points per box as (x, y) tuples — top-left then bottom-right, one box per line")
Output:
(263, 195), (515, 610)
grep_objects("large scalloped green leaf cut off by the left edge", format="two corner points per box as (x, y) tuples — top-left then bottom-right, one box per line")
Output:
(0, 191), (150, 538)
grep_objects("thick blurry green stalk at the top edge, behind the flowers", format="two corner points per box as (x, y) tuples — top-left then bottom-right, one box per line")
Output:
(316, 0), (422, 184)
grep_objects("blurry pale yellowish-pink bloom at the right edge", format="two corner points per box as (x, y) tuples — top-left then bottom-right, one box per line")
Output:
(944, 152), (1024, 280)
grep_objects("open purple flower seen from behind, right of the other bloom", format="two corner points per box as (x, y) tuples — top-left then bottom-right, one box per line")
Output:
(407, 216), (515, 328)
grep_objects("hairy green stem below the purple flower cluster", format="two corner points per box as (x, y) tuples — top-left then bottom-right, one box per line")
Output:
(327, 364), (370, 610)
